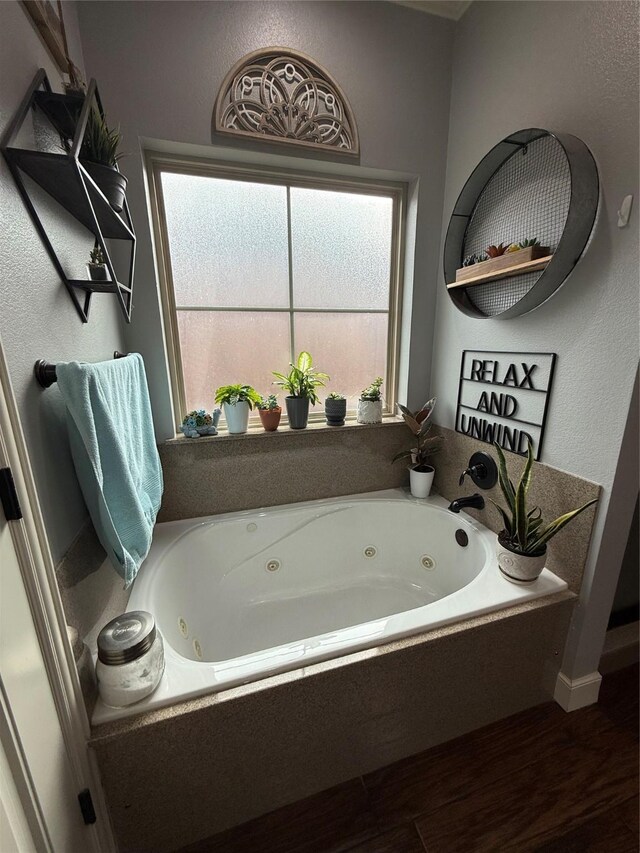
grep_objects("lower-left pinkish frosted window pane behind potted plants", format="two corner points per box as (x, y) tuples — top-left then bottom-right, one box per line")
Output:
(178, 311), (290, 411)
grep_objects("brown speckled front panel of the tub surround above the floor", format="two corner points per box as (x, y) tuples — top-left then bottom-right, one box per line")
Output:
(91, 591), (575, 853)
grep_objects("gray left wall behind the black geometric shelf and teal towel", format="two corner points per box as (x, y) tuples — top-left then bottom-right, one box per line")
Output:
(0, 2), (124, 561)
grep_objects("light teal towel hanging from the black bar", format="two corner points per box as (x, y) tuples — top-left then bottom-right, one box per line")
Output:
(56, 353), (162, 586)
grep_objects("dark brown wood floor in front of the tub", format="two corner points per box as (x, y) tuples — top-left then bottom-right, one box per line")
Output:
(179, 665), (639, 853)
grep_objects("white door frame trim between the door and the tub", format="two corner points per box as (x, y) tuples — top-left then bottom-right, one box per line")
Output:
(0, 338), (116, 853)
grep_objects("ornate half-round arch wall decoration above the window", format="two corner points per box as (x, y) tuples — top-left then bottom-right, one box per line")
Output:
(214, 47), (360, 155)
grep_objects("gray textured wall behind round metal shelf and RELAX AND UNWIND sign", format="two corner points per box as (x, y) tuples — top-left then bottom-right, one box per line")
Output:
(431, 2), (639, 678)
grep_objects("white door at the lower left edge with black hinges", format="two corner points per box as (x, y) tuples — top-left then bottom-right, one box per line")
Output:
(0, 480), (93, 853)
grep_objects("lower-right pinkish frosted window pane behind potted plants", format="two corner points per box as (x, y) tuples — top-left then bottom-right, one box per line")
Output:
(295, 313), (387, 409)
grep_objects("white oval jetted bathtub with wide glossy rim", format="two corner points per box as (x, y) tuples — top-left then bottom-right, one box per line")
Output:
(93, 489), (567, 724)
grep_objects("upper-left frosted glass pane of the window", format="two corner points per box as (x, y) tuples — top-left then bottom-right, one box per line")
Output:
(162, 172), (289, 308)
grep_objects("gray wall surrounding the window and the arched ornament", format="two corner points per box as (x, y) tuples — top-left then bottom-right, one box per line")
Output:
(79, 2), (455, 438)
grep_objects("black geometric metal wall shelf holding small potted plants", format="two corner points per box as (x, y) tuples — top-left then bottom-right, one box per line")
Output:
(0, 68), (136, 323)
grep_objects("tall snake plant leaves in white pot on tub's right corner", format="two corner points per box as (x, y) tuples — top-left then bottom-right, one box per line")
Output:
(489, 441), (598, 557)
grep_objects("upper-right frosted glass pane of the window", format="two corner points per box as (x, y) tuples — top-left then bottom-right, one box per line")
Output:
(291, 187), (393, 310)
